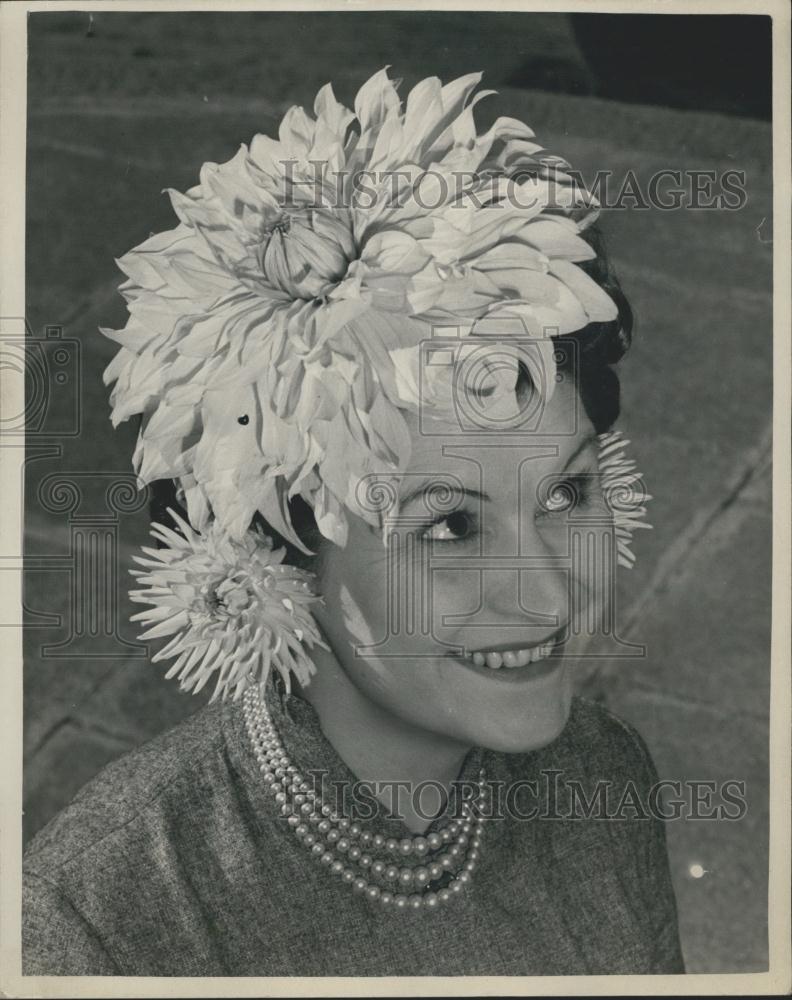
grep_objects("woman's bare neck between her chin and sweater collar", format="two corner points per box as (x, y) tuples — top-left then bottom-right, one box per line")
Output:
(299, 647), (470, 833)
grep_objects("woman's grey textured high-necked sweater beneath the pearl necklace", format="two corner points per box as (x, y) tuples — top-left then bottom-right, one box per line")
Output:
(23, 685), (684, 976)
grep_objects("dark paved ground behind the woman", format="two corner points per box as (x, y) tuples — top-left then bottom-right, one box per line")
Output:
(24, 12), (772, 972)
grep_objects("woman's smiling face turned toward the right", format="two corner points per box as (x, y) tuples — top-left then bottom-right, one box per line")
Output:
(316, 383), (611, 752)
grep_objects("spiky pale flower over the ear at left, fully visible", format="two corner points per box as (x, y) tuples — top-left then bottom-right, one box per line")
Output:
(130, 511), (325, 701)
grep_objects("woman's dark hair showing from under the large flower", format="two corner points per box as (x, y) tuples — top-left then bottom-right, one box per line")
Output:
(150, 226), (633, 572)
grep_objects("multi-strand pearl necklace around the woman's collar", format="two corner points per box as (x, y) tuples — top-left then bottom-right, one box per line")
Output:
(242, 687), (486, 910)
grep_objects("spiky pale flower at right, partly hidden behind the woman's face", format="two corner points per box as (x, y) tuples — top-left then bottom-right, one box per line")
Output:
(599, 431), (652, 569)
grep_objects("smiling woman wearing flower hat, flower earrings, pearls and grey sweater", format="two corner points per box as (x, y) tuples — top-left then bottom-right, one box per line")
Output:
(24, 71), (683, 976)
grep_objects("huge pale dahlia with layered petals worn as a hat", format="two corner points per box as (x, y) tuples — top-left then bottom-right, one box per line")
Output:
(103, 70), (616, 547)
